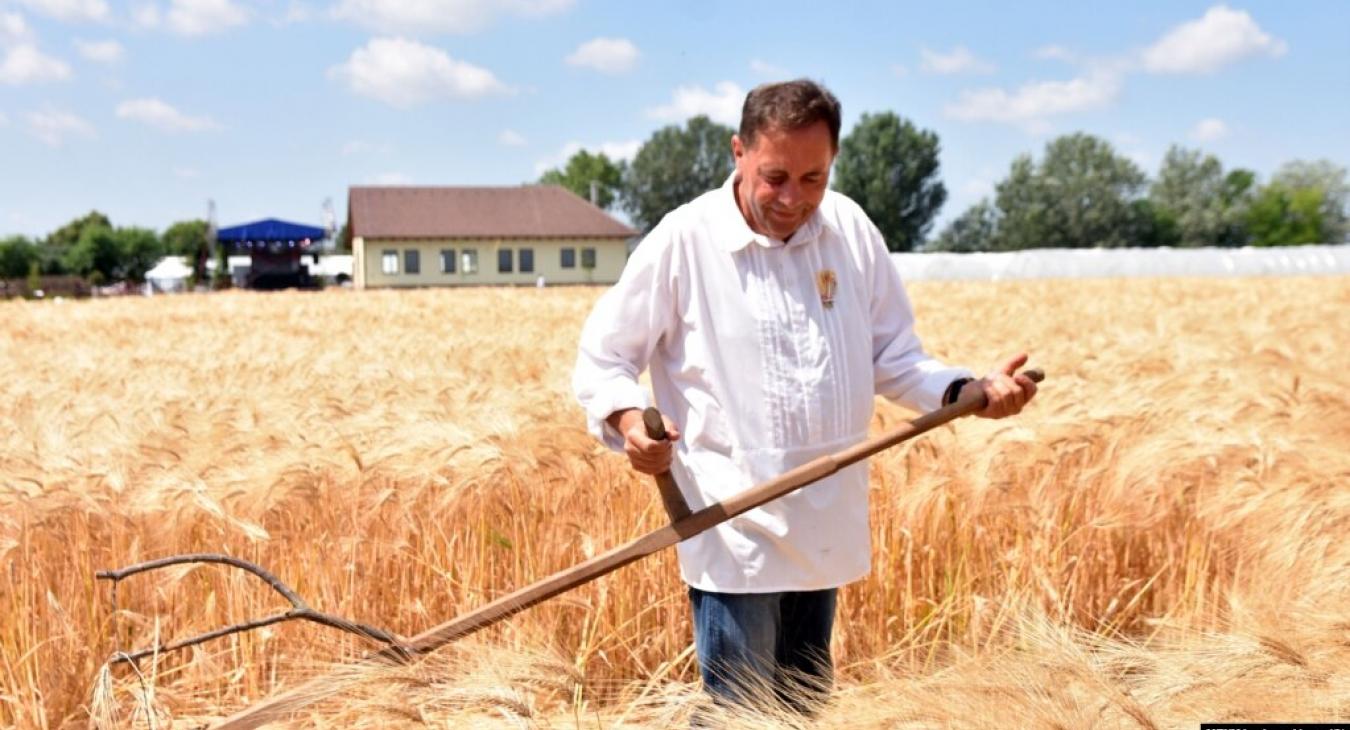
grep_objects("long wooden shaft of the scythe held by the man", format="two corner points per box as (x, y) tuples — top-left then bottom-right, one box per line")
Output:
(215, 368), (1045, 730)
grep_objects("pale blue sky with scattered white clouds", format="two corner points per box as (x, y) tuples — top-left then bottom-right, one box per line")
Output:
(0, 0), (1350, 236)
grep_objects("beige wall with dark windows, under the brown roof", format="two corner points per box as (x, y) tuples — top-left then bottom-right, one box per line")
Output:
(352, 237), (628, 289)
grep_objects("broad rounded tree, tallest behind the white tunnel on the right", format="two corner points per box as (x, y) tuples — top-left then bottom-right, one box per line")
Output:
(995, 132), (1145, 250)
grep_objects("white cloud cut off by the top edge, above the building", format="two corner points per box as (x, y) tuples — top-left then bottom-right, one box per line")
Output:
(331, 0), (574, 35)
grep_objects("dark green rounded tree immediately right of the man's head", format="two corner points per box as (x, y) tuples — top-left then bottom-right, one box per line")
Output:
(834, 112), (946, 251)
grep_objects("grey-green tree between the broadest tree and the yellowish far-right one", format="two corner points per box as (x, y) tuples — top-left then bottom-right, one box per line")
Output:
(1149, 144), (1251, 247)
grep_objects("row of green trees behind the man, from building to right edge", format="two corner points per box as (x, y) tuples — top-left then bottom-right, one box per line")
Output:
(539, 112), (1350, 251)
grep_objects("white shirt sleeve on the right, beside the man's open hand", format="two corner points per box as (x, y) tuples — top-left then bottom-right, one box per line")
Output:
(864, 224), (972, 413)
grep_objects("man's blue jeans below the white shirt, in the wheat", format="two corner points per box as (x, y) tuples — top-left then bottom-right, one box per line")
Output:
(689, 587), (838, 714)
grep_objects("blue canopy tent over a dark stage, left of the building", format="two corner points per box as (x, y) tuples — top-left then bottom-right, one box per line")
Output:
(216, 219), (328, 289)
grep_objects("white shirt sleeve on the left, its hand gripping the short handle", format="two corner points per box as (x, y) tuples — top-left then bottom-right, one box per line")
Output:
(572, 225), (675, 451)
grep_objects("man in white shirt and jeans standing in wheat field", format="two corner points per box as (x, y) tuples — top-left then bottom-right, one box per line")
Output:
(574, 80), (1035, 710)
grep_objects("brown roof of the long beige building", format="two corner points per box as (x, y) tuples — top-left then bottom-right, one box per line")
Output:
(347, 185), (637, 239)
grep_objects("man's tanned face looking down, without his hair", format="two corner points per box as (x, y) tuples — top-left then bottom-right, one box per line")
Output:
(732, 121), (834, 240)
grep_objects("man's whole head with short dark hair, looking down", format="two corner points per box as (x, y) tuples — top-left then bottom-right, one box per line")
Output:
(732, 80), (840, 240)
